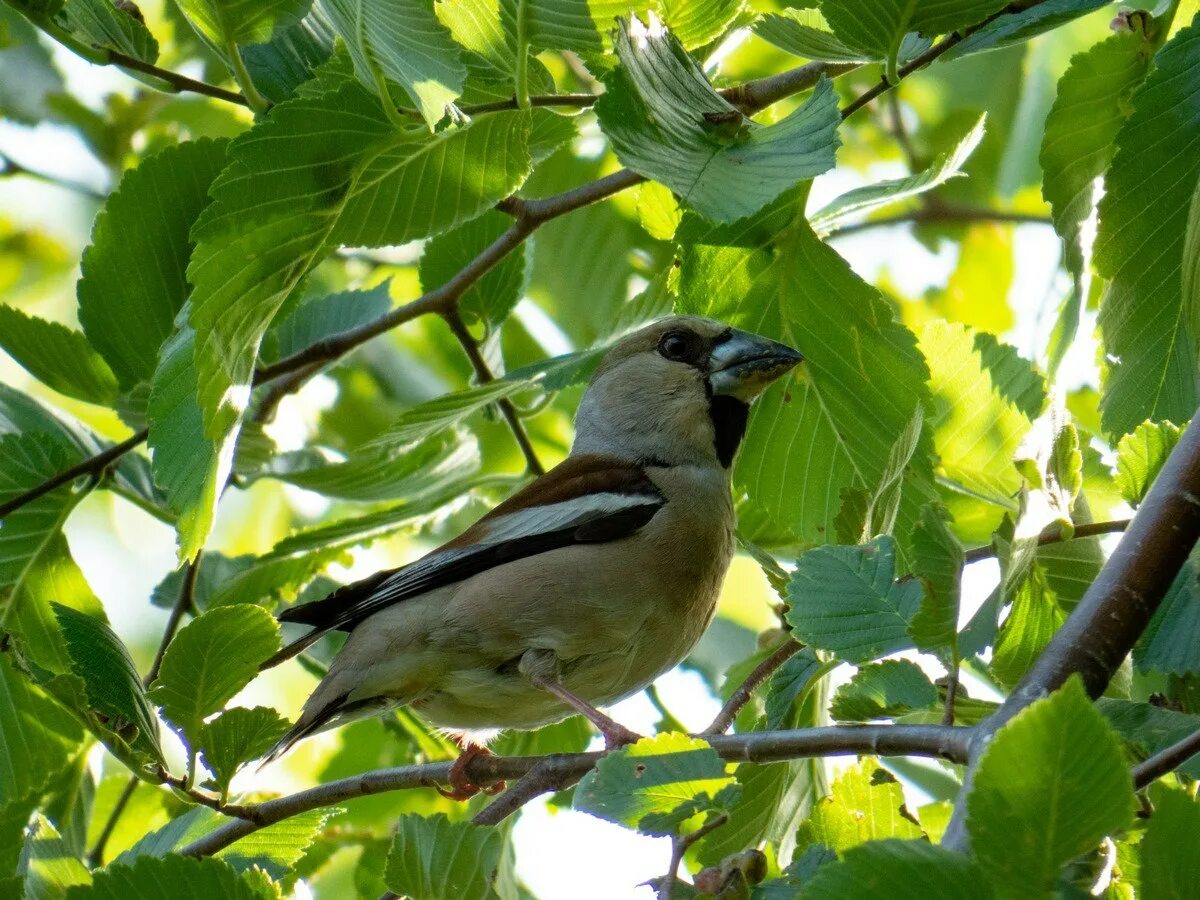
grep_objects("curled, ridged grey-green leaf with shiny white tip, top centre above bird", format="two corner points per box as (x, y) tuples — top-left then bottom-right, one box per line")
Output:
(595, 14), (840, 222)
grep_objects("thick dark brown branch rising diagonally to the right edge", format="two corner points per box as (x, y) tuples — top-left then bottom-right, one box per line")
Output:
(942, 416), (1200, 850)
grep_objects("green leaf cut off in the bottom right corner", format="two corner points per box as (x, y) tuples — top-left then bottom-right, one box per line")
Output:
(1138, 785), (1200, 900)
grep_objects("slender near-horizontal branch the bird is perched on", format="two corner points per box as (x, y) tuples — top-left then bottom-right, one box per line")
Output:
(180, 725), (971, 857)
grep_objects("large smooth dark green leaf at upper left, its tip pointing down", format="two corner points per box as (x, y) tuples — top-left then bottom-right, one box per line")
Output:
(76, 138), (228, 390)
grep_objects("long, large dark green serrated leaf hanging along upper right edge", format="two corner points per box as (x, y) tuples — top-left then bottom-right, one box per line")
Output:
(1096, 22), (1200, 434)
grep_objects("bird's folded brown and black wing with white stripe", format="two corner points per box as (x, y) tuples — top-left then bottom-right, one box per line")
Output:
(263, 455), (666, 668)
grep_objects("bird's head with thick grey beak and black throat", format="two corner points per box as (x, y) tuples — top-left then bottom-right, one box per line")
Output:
(574, 316), (803, 467)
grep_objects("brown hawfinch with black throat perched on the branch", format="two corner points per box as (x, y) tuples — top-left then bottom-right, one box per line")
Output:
(264, 316), (803, 799)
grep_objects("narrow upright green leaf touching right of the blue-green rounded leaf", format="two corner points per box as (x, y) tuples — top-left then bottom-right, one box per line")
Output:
(908, 504), (964, 660)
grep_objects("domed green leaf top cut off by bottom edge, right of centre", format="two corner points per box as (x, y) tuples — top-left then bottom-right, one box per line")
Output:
(804, 839), (992, 900)
